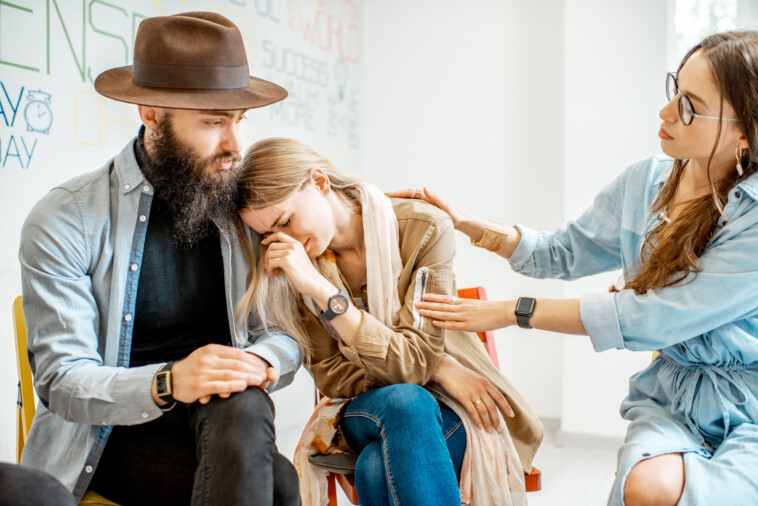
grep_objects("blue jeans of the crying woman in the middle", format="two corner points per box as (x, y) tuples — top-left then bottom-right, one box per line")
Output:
(341, 384), (466, 506)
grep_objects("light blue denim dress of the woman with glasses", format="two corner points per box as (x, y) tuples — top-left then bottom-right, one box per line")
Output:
(510, 157), (758, 505)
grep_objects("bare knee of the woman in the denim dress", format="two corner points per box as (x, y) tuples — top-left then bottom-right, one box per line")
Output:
(624, 453), (684, 506)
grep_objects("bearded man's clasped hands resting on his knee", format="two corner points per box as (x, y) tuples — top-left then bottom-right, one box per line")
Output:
(152, 344), (278, 406)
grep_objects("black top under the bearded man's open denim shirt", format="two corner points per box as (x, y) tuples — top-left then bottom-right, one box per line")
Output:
(130, 138), (231, 367)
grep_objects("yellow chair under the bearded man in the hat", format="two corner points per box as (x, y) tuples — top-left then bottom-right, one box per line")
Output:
(13, 295), (118, 506)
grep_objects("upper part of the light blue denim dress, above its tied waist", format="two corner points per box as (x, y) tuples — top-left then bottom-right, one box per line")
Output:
(510, 157), (758, 366)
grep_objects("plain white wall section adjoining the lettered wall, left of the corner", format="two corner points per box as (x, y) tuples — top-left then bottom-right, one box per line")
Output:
(364, 0), (563, 417)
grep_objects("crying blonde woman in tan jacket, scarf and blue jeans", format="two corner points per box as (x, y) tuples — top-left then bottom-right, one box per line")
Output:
(240, 139), (542, 506)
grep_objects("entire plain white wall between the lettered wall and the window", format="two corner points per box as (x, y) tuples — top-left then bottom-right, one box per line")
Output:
(364, 0), (666, 446)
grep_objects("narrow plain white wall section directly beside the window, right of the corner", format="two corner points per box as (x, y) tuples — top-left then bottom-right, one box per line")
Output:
(561, 0), (667, 437)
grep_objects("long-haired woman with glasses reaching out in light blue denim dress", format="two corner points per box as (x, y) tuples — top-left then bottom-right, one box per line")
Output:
(395, 31), (758, 505)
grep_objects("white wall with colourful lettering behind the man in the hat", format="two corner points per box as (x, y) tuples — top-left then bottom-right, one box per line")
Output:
(0, 0), (363, 461)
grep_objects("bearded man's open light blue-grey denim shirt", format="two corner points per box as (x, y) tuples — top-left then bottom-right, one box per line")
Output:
(19, 140), (300, 497)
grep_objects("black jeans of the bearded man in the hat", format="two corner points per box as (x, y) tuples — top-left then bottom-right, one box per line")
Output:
(90, 387), (300, 506)
